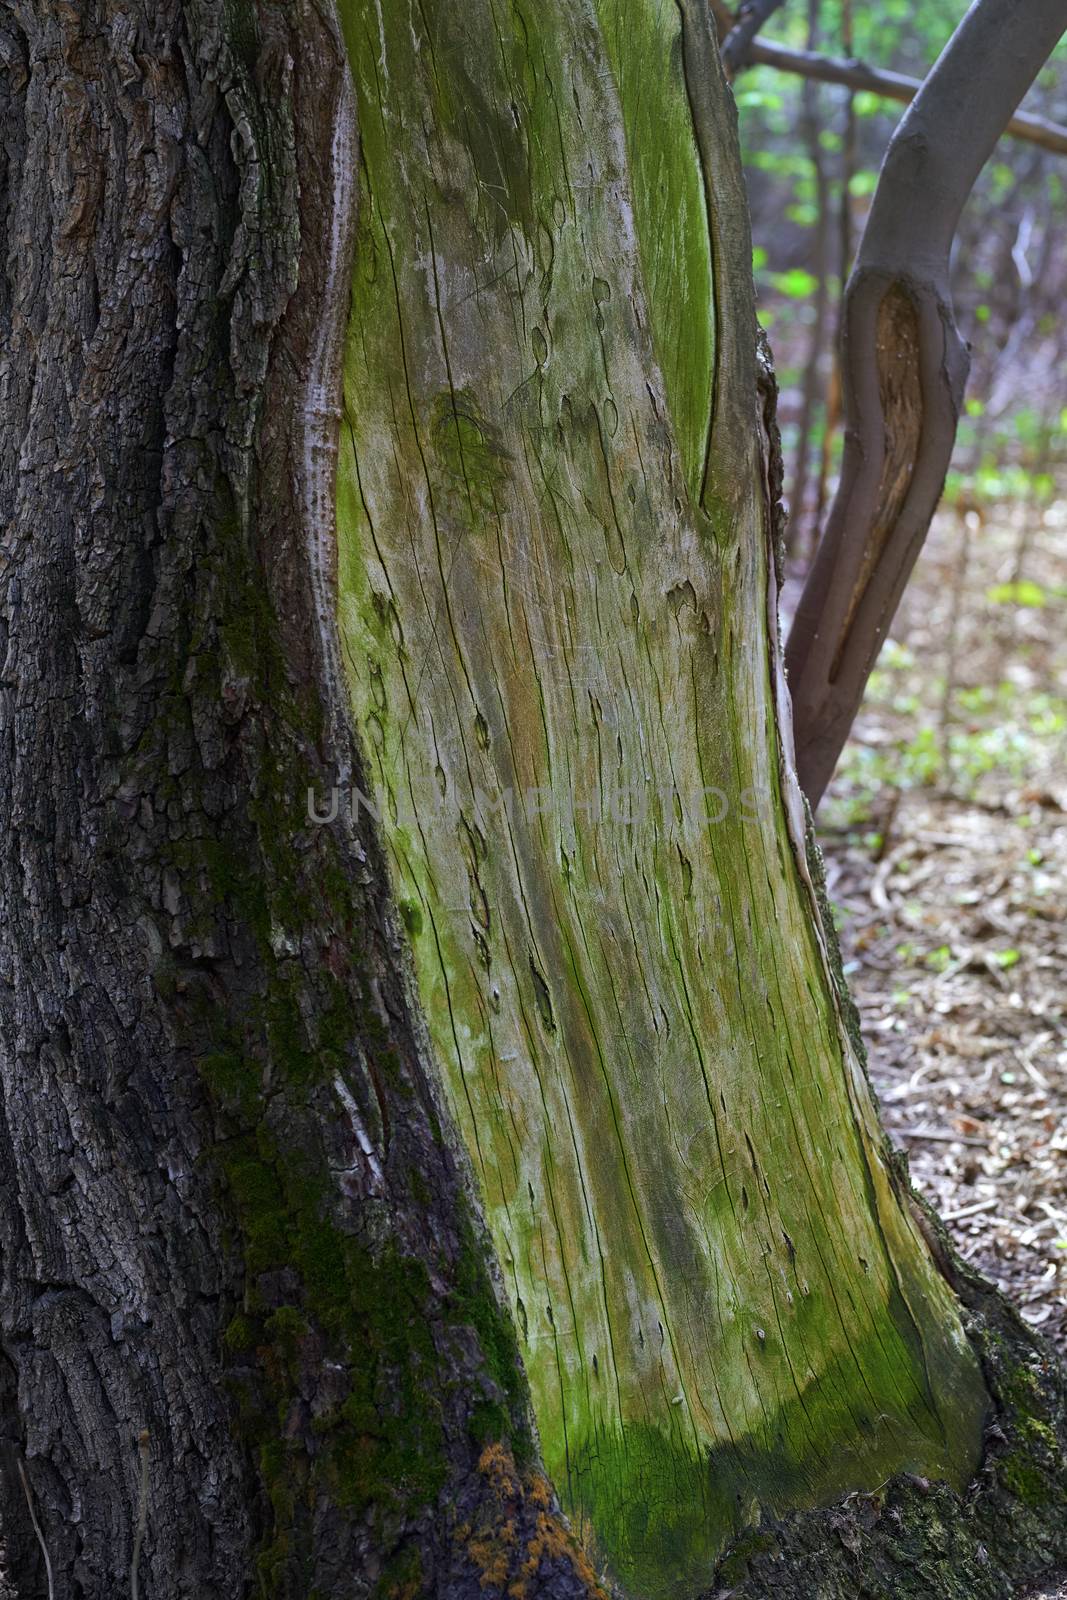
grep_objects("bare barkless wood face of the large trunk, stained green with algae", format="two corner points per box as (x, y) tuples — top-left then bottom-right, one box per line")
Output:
(338, 0), (984, 1597)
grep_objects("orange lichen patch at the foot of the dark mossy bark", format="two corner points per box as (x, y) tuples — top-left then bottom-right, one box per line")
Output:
(453, 1443), (603, 1600)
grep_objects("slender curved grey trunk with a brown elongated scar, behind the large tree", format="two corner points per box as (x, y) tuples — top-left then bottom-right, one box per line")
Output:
(785, 0), (1067, 806)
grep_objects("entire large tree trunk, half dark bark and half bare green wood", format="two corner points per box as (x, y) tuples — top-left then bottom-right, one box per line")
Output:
(0, 0), (1059, 1600)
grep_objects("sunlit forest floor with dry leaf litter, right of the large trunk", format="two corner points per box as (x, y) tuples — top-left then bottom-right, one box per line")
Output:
(819, 504), (1067, 1350)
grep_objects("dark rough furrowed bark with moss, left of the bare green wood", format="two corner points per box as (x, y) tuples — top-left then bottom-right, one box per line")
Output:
(0, 0), (589, 1600)
